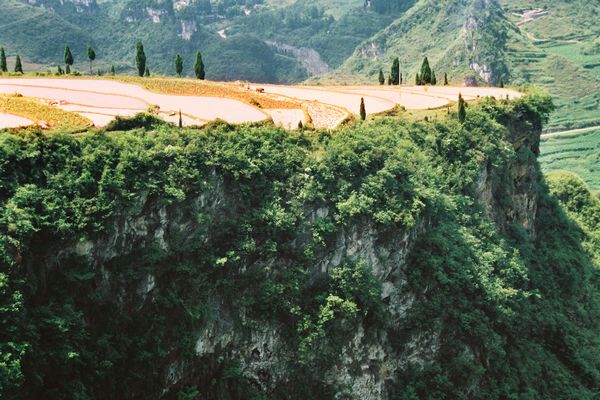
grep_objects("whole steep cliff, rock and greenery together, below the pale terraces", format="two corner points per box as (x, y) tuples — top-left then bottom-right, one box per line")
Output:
(1, 96), (594, 399)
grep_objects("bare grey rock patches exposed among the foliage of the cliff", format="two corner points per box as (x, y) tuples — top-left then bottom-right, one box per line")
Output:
(22, 115), (541, 400)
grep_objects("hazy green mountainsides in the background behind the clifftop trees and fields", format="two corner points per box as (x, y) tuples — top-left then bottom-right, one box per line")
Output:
(0, 0), (600, 128)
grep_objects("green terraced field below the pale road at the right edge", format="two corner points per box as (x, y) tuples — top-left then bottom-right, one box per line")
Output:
(539, 129), (600, 191)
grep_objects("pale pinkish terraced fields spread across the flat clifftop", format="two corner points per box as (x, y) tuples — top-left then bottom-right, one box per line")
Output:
(0, 77), (521, 129)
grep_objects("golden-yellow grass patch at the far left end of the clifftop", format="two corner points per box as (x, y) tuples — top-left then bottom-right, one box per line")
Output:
(0, 95), (92, 131)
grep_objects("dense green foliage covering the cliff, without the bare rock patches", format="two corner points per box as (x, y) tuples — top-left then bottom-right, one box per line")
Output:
(0, 96), (600, 399)
